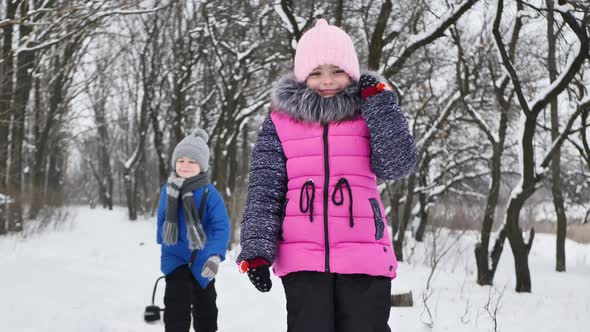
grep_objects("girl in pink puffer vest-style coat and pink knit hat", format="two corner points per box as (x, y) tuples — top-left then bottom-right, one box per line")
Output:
(238, 19), (417, 332)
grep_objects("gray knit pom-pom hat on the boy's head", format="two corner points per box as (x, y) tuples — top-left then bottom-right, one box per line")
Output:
(172, 128), (209, 172)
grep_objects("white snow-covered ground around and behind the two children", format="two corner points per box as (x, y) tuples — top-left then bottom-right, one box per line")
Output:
(0, 208), (590, 332)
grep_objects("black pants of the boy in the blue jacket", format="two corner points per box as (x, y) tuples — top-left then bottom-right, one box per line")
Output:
(164, 265), (217, 332)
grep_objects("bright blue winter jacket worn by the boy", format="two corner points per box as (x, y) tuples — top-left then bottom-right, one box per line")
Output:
(157, 184), (229, 288)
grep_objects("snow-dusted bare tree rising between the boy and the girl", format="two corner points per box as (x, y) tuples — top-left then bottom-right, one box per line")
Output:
(202, 1), (286, 218)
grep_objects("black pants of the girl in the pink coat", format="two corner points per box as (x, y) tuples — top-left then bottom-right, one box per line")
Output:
(282, 271), (391, 332)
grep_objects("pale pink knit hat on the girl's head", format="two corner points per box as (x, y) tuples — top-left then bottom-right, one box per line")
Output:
(295, 18), (360, 82)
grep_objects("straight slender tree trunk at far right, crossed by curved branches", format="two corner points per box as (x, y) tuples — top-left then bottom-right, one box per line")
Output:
(546, 0), (567, 272)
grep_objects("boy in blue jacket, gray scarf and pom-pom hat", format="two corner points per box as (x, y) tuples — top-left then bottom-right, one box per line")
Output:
(157, 129), (230, 332)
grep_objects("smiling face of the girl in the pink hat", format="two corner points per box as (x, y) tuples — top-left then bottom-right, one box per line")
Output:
(305, 65), (351, 98)
